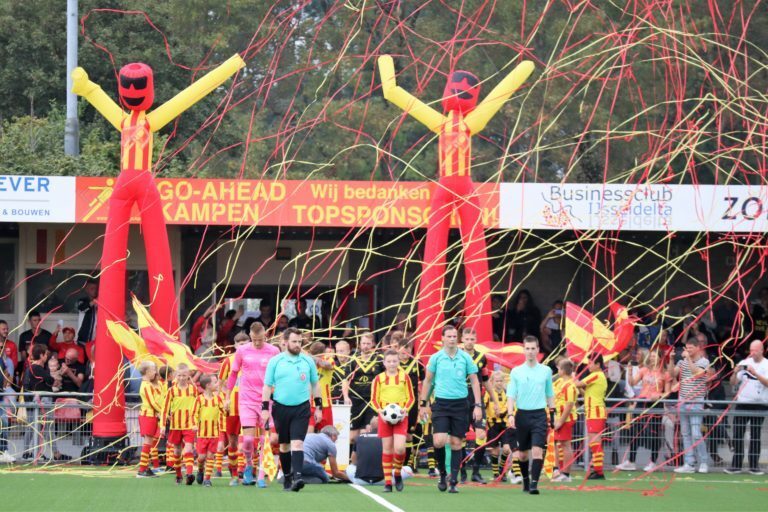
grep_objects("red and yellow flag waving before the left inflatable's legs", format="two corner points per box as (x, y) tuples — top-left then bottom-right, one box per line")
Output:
(107, 296), (220, 373)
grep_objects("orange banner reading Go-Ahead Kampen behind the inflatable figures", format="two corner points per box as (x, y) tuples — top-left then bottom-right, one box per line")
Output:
(76, 177), (499, 228)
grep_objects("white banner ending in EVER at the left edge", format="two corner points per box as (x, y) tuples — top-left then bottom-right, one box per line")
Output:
(0, 176), (75, 222)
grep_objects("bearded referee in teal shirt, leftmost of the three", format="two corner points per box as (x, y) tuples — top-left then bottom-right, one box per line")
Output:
(261, 328), (323, 492)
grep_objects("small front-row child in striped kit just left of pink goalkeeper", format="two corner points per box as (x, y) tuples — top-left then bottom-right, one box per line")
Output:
(195, 374), (224, 487)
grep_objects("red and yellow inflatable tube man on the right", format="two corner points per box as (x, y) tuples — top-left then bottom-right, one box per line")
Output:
(379, 55), (533, 356)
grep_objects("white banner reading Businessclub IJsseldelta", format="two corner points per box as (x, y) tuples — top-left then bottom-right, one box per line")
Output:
(499, 183), (768, 233)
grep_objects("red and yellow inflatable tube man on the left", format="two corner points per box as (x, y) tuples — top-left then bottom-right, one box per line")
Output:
(72, 54), (245, 438)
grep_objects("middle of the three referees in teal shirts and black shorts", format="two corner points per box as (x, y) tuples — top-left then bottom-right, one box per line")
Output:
(419, 325), (483, 494)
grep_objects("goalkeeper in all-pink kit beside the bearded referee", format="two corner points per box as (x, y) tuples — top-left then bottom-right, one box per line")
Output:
(226, 322), (280, 485)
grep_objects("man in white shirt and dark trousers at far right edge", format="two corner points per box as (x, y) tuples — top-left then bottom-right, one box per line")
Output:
(725, 340), (768, 475)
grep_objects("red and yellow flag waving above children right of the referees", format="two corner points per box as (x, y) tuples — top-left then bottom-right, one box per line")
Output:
(565, 302), (635, 363)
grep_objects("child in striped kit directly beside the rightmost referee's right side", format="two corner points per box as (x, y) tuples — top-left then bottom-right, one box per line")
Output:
(552, 358), (579, 482)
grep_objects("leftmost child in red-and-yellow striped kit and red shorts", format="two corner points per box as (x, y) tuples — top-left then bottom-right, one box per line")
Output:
(136, 361), (165, 478)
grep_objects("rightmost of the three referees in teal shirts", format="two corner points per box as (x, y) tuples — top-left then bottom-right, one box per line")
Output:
(507, 336), (555, 494)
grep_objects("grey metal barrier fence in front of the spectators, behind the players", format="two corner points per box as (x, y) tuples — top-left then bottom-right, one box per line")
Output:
(0, 393), (768, 471)
